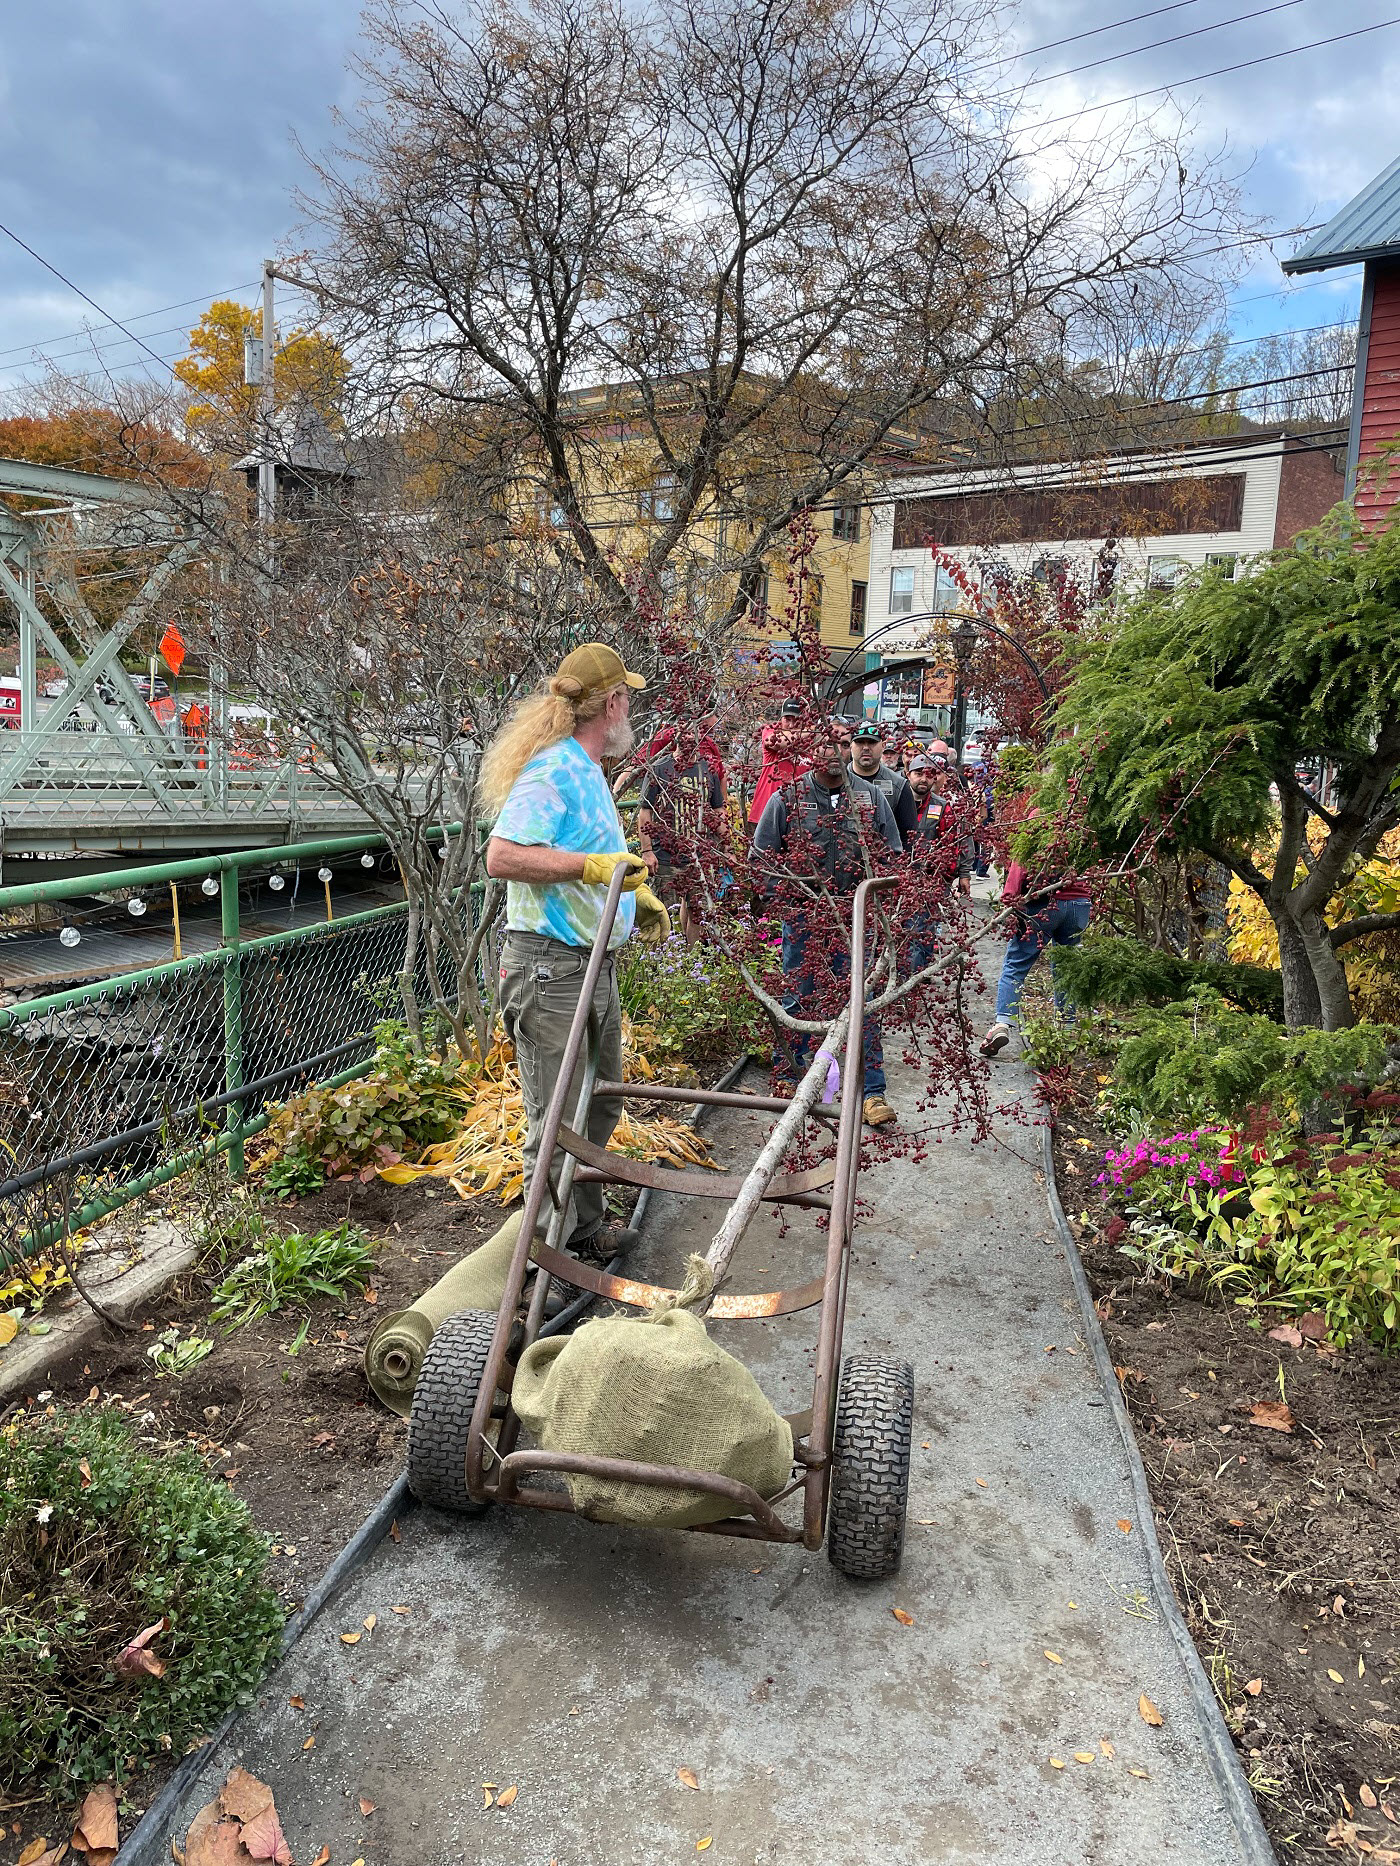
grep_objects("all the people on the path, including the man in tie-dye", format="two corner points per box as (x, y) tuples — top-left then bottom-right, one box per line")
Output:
(482, 642), (1090, 1258)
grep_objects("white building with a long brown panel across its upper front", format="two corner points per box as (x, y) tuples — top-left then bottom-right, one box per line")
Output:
(866, 435), (1342, 730)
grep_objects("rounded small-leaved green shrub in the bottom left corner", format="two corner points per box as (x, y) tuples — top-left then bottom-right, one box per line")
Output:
(0, 1413), (282, 1799)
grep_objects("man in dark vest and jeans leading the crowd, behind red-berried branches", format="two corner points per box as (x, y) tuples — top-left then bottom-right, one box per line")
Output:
(754, 726), (907, 1127)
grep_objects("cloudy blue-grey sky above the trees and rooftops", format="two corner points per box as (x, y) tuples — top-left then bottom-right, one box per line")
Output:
(0, 0), (1400, 392)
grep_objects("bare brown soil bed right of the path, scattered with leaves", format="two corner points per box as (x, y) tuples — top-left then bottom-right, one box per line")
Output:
(1051, 1058), (1400, 1866)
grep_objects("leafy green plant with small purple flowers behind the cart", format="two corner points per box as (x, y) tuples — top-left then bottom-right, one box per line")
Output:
(618, 933), (782, 1064)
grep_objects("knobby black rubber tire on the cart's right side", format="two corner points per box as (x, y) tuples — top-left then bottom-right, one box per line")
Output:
(827, 1355), (915, 1581)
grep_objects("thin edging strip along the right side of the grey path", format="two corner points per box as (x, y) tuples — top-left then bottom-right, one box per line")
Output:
(1040, 1125), (1279, 1866)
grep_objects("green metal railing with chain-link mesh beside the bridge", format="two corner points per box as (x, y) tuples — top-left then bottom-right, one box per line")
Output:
(0, 825), (480, 1265)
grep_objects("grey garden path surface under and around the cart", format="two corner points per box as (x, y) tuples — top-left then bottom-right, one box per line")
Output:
(167, 1062), (1269, 1866)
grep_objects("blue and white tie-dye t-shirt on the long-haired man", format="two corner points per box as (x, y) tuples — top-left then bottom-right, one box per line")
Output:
(491, 737), (637, 950)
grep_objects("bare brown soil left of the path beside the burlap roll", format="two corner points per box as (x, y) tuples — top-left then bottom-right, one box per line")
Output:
(0, 1181), (504, 1866)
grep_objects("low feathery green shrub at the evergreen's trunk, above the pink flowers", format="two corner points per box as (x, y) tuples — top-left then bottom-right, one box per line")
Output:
(1109, 987), (1394, 1133)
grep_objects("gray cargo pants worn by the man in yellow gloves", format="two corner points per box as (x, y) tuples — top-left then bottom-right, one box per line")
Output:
(500, 931), (622, 1243)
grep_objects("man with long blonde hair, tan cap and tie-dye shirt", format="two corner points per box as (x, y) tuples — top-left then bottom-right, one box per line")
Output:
(480, 642), (668, 1260)
